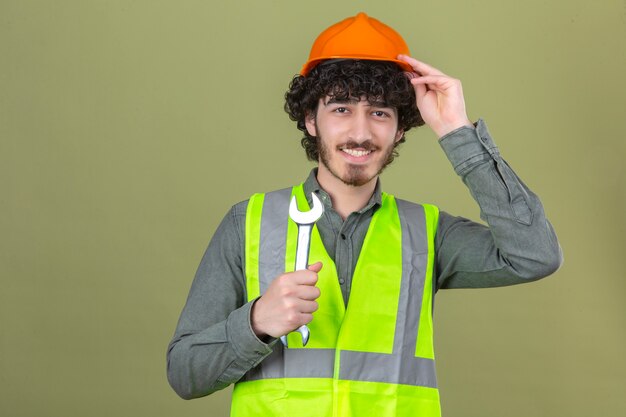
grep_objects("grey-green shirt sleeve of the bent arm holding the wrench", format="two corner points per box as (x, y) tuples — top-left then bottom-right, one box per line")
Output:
(167, 202), (275, 399)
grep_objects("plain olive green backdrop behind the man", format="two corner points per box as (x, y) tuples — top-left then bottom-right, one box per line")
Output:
(0, 0), (626, 417)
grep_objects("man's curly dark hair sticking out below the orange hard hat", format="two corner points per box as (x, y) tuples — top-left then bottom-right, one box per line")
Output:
(285, 59), (424, 162)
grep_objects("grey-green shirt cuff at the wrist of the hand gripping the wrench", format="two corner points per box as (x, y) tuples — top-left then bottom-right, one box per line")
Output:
(226, 299), (275, 366)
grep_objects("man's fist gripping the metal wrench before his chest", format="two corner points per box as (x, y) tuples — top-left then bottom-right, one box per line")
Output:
(251, 262), (322, 338)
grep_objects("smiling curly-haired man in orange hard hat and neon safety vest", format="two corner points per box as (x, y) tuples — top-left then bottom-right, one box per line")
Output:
(168, 13), (562, 417)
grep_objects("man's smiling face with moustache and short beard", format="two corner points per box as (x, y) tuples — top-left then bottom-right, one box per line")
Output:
(306, 97), (404, 187)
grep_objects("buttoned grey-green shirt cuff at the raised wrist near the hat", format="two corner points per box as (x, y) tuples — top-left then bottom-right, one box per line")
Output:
(439, 118), (499, 176)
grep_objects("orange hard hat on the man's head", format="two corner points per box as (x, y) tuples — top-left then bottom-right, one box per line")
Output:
(300, 13), (413, 75)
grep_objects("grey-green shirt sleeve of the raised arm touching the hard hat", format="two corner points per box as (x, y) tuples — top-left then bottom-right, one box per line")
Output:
(435, 119), (563, 288)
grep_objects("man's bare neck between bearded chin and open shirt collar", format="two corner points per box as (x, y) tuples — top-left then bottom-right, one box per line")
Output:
(317, 164), (378, 220)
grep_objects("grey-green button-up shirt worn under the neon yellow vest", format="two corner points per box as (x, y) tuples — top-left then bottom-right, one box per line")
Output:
(167, 119), (562, 398)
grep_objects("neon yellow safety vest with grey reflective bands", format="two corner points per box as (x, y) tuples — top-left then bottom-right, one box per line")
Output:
(231, 184), (441, 417)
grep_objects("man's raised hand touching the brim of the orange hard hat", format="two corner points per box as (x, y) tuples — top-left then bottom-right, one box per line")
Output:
(398, 55), (474, 138)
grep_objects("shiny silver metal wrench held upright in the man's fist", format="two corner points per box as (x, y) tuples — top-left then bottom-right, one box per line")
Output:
(280, 194), (324, 347)
